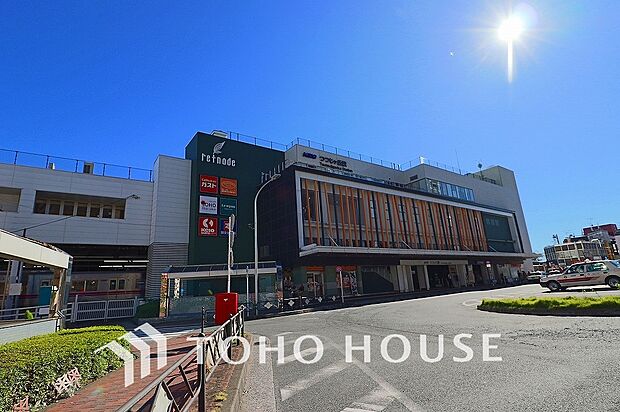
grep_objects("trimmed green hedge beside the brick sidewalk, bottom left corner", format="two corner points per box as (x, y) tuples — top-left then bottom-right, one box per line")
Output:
(0, 326), (128, 411)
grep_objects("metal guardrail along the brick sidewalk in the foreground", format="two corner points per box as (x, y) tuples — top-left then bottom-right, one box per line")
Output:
(117, 306), (245, 412)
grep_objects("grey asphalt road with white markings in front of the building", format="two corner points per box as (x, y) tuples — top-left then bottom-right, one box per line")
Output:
(247, 285), (620, 412)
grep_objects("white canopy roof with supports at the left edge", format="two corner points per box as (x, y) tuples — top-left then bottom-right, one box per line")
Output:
(0, 229), (73, 316)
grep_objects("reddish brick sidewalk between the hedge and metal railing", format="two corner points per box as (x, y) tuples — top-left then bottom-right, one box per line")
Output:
(45, 335), (196, 412)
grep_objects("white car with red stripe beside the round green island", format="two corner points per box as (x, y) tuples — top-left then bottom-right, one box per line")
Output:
(540, 260), (620, 292)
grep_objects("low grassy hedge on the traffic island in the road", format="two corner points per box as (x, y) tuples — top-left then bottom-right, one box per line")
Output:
(478, 296), (620, 310)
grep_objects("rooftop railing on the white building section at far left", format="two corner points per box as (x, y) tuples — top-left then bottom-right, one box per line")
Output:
(0, 149), (153, 182)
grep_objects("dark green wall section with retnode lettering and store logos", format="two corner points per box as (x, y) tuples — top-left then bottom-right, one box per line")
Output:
(185, 132), (284, 264)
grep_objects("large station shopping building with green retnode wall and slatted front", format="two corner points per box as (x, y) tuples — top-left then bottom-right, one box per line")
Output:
(0, 132), (533, 313)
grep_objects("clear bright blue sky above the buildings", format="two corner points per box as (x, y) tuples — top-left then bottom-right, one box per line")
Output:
(0, 0), (620, 251)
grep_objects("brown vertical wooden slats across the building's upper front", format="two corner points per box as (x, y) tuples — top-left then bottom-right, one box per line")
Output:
(301, 179), (489, 251)
